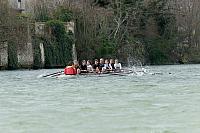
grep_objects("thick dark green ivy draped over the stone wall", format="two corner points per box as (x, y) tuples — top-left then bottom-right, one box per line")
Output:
(44, 20), (74, 68)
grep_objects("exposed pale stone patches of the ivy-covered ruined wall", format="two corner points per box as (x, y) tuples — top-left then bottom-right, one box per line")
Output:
(0, 22), (74, 69)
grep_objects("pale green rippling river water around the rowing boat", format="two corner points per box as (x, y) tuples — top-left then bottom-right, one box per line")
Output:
(0, 65), (200, 133)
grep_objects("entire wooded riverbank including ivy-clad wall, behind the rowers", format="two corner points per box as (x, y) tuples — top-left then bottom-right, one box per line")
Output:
(0, 0), (200, 70)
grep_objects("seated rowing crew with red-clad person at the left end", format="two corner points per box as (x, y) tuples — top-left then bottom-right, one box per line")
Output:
(64, 58), (122, 75)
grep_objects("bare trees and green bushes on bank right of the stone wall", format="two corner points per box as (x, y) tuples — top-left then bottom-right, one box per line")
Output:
(72, 0), (200, 64)
